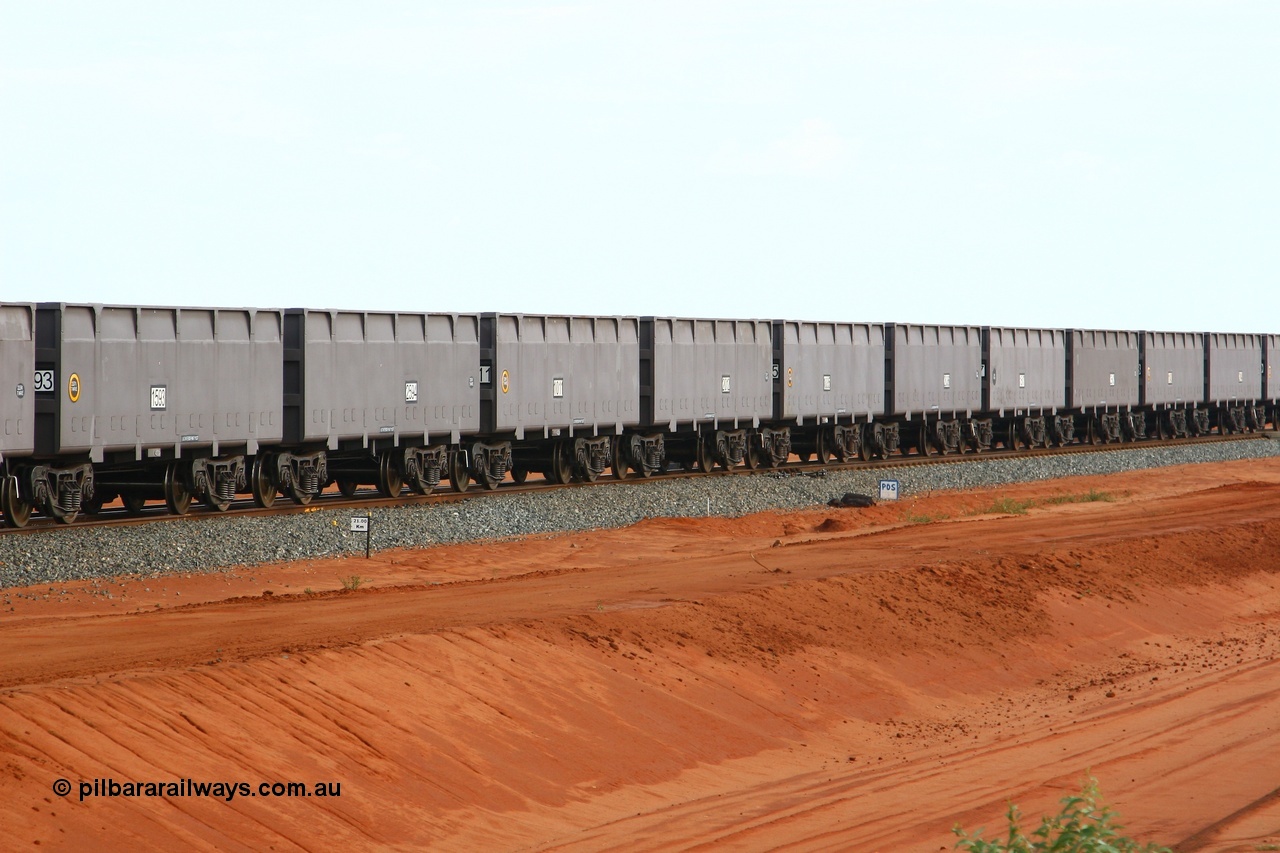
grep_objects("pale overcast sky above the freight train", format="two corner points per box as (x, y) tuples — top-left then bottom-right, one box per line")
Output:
(0, 0), (1280, 332)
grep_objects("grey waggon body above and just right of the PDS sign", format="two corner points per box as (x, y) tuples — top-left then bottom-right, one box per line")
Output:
(886, 323), (982, 416)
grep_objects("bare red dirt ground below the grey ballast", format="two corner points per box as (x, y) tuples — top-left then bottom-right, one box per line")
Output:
(0, 461), (1280, 852)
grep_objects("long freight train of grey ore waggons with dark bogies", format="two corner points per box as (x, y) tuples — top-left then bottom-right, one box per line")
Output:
(0, 298), (1280, 526)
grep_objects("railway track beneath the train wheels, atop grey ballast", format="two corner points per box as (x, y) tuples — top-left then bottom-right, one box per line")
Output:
(0, 432), (1280, 535)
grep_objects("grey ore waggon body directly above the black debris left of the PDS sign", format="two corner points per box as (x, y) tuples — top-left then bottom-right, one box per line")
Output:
(773, 320), (884, 423)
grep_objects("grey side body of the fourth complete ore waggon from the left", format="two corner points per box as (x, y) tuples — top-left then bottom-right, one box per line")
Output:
(641, 318), (773, 429)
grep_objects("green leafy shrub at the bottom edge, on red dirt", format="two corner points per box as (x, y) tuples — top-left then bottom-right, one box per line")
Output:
(952, 776), (1170, 853)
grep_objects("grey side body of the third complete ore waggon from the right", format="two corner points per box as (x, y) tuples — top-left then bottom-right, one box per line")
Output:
(1068, 329), (1140, 410)
